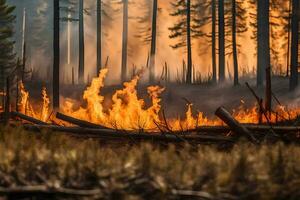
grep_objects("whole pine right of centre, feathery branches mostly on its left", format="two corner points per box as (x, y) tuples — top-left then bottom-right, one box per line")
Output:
(169, 0), (197, 84)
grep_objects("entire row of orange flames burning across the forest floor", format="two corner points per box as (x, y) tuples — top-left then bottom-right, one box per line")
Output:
(19, 69), (300, 132)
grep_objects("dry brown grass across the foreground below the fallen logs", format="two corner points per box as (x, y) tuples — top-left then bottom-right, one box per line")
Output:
(0, 127), (300, 199)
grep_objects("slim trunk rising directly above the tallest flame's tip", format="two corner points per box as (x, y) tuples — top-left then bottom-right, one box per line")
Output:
(96, 0), (102, 75)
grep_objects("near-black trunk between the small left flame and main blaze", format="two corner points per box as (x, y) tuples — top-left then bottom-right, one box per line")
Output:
(52, 0), (60, 109)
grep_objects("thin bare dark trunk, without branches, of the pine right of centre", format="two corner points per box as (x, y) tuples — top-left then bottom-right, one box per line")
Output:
(186, 0), (193, 84)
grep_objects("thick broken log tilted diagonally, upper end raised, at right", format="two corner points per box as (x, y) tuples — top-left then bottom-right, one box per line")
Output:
(215, 107), (259, 144)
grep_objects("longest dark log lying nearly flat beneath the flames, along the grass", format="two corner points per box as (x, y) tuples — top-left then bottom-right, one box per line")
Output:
(24, 125), (234, 143)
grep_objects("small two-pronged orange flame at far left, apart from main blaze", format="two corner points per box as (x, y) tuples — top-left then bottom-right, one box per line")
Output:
(18, 82), (50, 122)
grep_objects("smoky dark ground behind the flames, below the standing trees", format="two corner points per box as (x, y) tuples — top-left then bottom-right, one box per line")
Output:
(25, 77), (300, 117)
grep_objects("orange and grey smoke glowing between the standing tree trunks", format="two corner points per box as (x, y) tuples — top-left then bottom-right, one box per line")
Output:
(9, 0), (287, 84)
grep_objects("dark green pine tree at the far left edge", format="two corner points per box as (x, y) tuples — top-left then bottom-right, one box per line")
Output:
(0, 0), (16, 88)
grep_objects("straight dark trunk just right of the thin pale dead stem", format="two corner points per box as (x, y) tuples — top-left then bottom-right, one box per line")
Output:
(78, 0), (84, 84)
